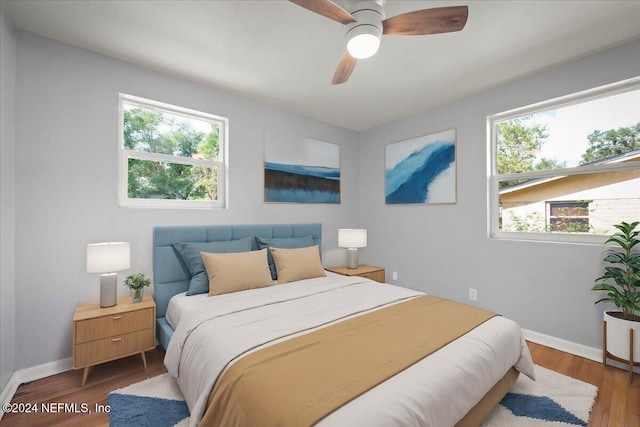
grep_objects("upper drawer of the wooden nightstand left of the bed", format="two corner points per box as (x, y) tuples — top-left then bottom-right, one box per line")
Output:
(75, 308), (155, 345)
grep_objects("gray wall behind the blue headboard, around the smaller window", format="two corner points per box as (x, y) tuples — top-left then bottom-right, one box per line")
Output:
(15, 32), (359, 369)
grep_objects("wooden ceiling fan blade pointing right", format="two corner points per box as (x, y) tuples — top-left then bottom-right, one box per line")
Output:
(382, 6), (469, 36)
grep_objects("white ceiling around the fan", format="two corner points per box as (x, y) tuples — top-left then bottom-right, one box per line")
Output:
(4, 0), (640, 130)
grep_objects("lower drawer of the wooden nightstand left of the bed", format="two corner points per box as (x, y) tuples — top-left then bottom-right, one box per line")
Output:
(73, 328), (155, 368)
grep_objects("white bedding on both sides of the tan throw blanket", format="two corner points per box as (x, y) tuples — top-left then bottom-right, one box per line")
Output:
(165, 273), (534, 427)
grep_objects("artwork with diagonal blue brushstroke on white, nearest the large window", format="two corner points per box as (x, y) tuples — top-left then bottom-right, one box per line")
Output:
(385, 129), (456, 205)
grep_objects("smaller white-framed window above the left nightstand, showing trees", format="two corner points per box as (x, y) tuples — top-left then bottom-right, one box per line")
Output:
(120, 94), (228, 208)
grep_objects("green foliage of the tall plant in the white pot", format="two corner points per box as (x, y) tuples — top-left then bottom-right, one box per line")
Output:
(591, 221), (640, 320)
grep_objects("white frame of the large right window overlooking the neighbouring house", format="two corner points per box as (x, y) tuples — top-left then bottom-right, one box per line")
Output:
(486, 77), (640, 245)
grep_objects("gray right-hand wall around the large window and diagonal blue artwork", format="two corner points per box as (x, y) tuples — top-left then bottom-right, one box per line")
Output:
(360, 38), (640, 348)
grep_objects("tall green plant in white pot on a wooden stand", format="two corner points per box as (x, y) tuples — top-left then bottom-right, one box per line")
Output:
(591, 221), (640, 380)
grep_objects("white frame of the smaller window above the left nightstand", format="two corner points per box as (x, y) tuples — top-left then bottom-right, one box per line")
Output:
(118, 93), (229, 209)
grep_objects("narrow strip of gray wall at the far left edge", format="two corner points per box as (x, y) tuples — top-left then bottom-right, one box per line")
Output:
(0, 3), (16, 391)
